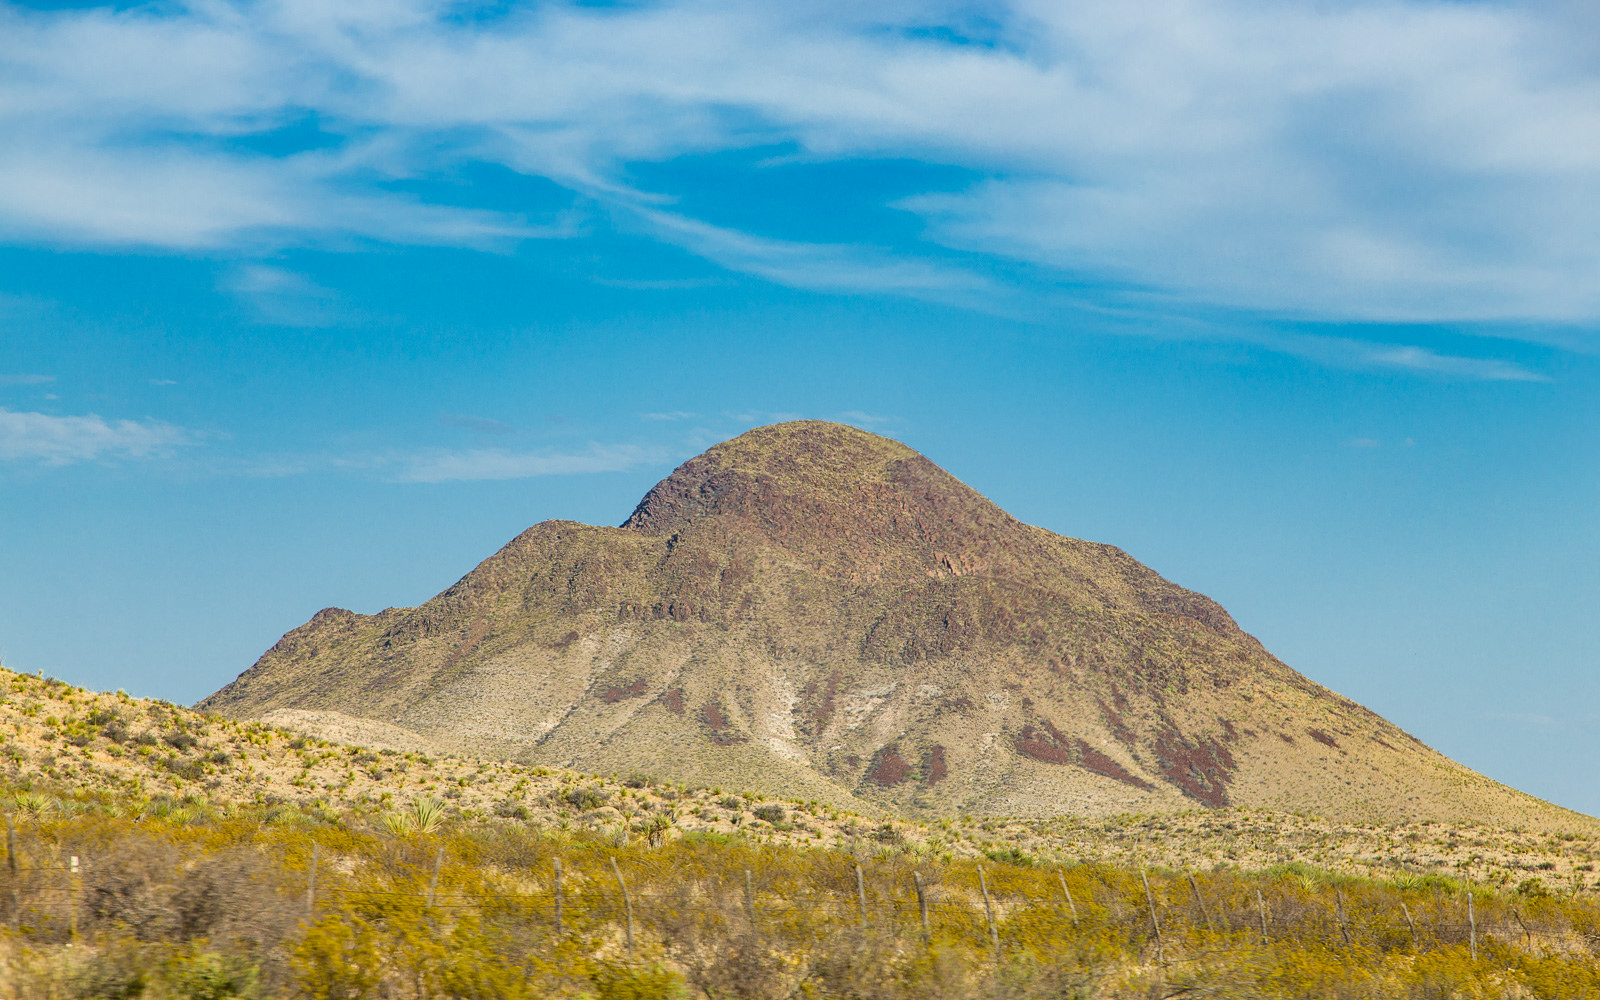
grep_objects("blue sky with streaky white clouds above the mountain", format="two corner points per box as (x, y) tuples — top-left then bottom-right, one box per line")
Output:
(0, 0), (1600, 813)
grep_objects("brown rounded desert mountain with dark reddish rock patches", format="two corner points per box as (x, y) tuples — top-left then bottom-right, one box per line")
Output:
(200, 421), (1581, 826)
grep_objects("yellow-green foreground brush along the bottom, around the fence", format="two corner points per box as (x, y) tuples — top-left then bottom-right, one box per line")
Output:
(0, 792), (1600, 1000)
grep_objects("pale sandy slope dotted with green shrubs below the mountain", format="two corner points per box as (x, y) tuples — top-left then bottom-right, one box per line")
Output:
(0, 670), (1600, 893)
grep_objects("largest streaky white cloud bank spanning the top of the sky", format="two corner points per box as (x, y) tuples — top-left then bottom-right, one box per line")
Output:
(0, 0), (1600, 320)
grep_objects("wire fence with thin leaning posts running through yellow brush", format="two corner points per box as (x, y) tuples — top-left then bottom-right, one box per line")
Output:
(0, 819), (1574, 962)
